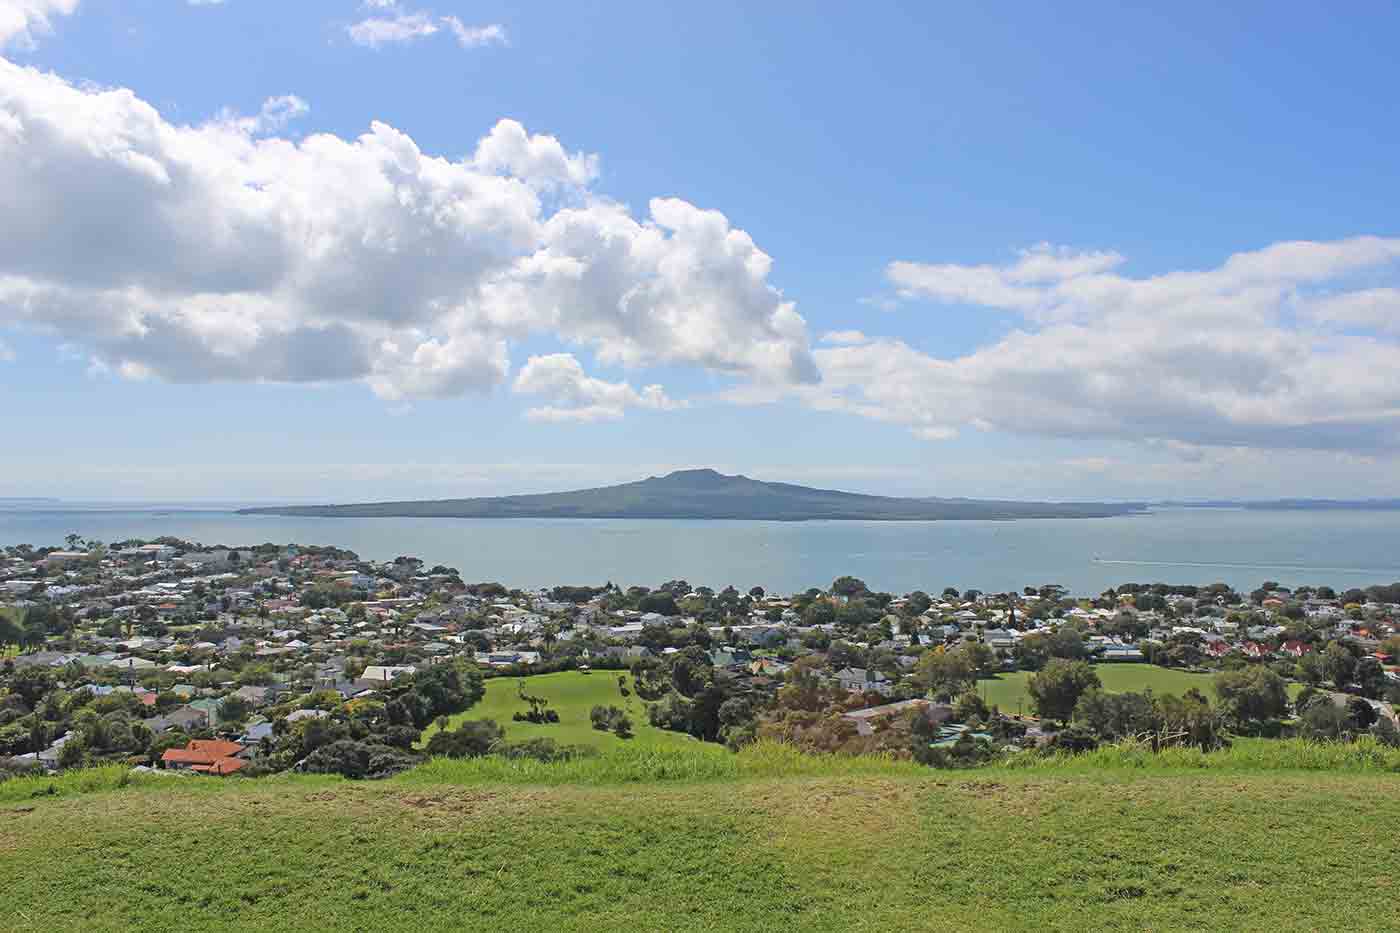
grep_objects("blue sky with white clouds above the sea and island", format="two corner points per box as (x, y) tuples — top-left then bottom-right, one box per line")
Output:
(0, 0), (1400, 502)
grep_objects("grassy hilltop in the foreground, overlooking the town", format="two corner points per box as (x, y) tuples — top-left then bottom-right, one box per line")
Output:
(0, 742), (1400, 933)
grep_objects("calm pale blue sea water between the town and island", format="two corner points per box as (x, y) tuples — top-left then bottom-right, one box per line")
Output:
(0, 503), (1400, 593)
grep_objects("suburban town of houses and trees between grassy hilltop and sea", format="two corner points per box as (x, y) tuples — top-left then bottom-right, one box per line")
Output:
(0, 535), (1400, 778)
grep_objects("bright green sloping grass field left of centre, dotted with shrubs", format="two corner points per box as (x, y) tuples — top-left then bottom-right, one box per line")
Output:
(423, 671), (696, 751)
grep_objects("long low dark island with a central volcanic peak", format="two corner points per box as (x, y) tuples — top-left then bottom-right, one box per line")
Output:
(238, 469), (1147, 521)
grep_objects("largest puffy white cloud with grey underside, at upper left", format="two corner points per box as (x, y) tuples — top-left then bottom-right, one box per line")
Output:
(0, 59), (818, 408)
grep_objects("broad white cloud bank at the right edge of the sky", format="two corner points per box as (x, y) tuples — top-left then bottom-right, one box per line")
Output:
(805, 237), (1400, 451)
